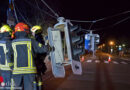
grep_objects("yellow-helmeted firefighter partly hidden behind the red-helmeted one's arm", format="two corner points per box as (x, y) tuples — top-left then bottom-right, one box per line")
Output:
(31, 25), (47, 88)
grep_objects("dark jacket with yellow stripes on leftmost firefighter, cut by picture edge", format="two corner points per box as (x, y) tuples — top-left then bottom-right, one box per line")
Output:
(0, 32), (13, 71)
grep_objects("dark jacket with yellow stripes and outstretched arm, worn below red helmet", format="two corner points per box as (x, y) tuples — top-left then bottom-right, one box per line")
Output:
(12, 32), (48, 74)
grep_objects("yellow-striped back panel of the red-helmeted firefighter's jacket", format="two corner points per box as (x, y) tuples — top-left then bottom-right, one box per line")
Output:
(12, 39), (36, 74)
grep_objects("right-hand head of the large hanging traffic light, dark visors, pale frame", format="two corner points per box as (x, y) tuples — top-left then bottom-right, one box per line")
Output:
(65, 22), (84, 75)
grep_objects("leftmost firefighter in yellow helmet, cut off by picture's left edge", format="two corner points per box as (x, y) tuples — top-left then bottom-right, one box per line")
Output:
(0, 25), (13, 90)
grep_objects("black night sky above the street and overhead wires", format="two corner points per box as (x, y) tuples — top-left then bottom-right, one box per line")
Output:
(0, 0), (130, 43)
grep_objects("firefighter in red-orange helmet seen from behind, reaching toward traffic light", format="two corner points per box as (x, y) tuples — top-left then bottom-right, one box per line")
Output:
(12, 22), (48, 90)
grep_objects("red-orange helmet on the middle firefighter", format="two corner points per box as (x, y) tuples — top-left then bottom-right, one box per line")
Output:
(15, 22), (29, 33)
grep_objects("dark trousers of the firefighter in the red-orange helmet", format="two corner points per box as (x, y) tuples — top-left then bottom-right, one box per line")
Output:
(13, 74), (37, 90)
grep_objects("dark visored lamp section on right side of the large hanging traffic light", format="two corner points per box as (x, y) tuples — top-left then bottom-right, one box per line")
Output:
(68, 26), (84, 59)
